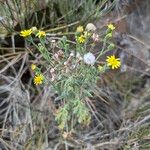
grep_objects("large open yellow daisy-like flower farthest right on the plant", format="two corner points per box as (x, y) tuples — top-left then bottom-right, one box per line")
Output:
(106, 55), (121, 69)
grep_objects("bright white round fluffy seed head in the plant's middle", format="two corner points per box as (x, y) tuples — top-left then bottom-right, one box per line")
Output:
(83, 52), (96, 65)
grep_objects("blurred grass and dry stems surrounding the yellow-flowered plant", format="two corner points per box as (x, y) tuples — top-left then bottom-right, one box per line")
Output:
(0, 0), (150, 150)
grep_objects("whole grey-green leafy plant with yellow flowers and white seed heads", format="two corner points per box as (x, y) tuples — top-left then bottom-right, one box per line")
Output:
(21, 23), (121, 131)
